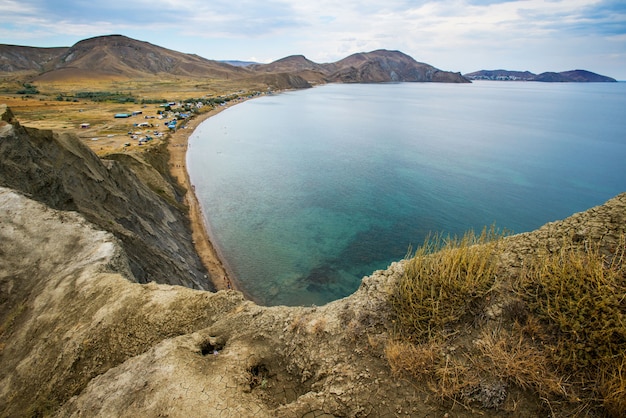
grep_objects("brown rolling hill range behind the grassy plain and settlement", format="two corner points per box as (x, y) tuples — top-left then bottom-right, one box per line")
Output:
(0, 35), (469, 88)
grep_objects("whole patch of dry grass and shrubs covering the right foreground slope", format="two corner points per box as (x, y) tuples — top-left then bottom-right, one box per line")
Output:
(386, 229), (626, 417)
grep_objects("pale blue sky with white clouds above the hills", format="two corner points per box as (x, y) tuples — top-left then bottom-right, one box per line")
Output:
(0, 0), (626, 80)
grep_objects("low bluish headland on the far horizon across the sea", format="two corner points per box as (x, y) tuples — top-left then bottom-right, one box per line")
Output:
(464, 70), (617, 83)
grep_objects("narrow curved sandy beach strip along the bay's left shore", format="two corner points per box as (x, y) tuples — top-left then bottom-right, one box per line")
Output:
(168, 105), (238, 290)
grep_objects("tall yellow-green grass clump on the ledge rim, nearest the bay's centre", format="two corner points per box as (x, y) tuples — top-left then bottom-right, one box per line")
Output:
(391, 228), (498, 342)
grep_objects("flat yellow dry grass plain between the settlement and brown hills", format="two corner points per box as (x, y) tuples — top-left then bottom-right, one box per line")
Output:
(0, 76), (267, 156)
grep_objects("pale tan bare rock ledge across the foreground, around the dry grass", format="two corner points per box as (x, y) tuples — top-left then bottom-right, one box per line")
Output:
(0, 188), (626, 417)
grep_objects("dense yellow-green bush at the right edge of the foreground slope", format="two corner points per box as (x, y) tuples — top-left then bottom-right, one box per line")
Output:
(517, 237), (626, 416)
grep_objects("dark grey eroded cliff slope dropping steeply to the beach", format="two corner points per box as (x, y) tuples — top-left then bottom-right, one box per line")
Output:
(0, 105), (212, 289)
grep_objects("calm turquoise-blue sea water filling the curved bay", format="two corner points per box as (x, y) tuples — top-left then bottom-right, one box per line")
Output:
(187, 82), (626, 305)
